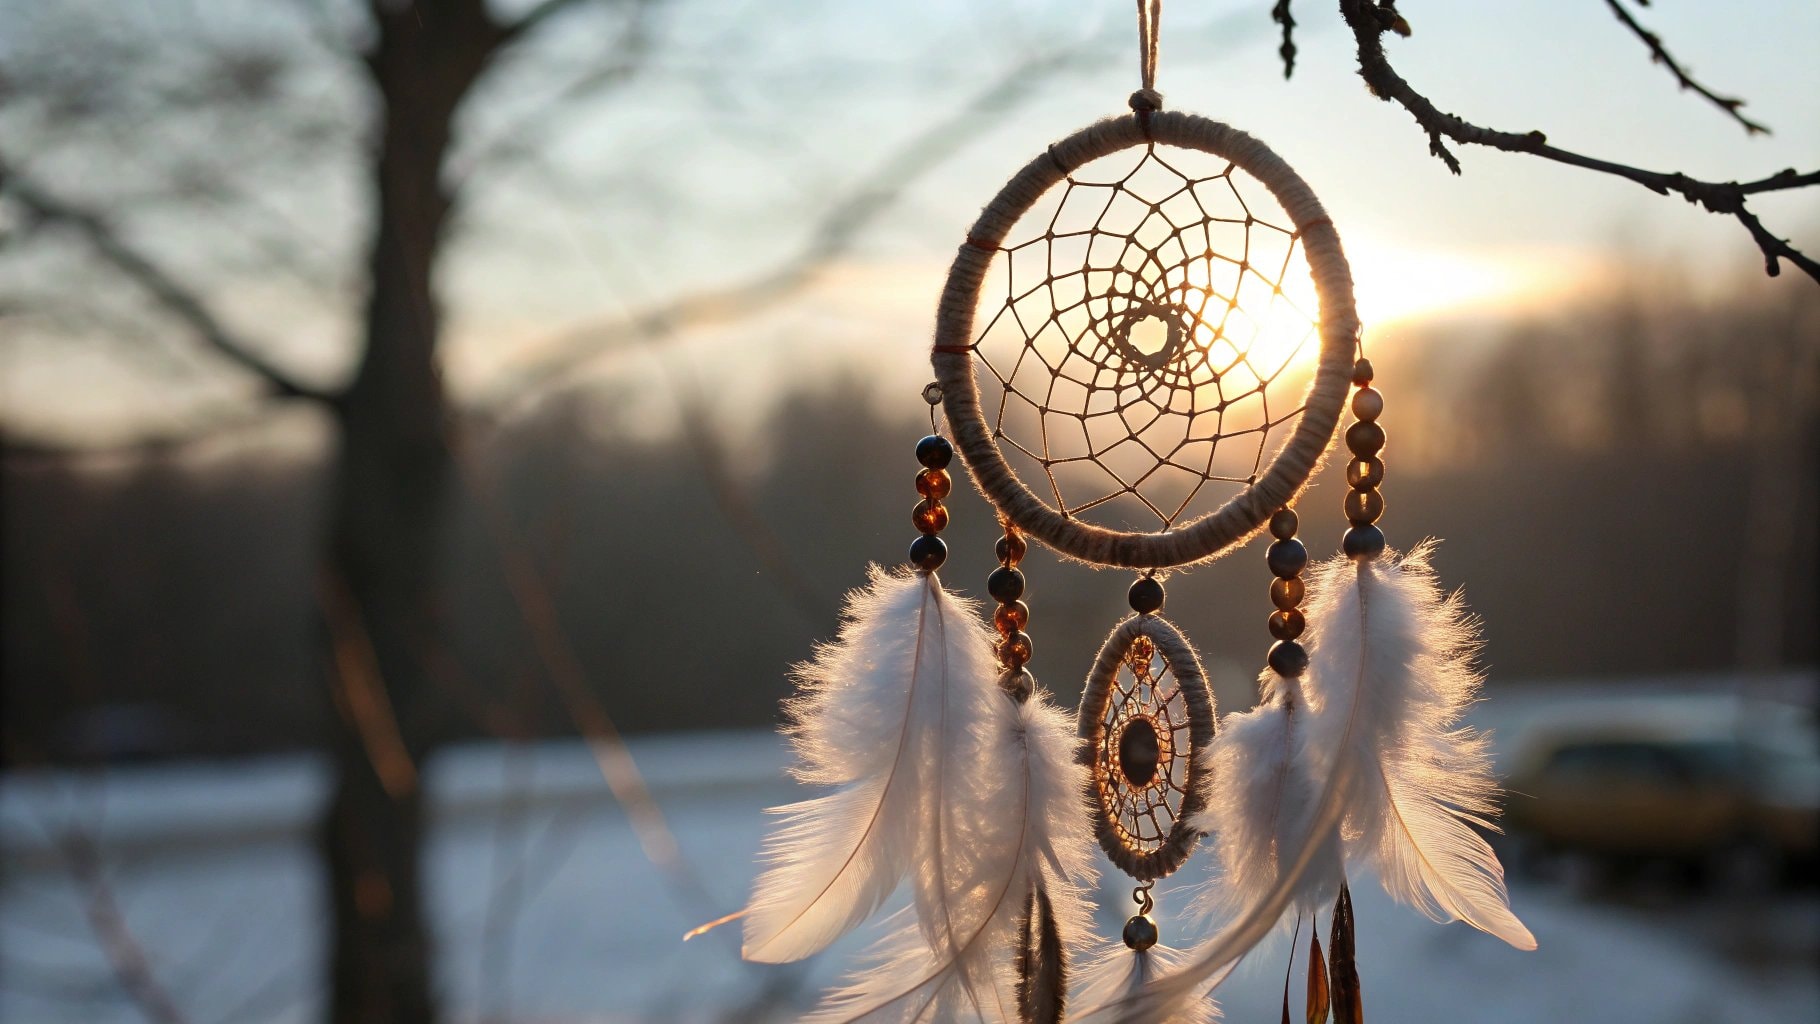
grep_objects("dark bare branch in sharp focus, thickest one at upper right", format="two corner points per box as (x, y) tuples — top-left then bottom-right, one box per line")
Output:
(1340, 0), (1820, 282)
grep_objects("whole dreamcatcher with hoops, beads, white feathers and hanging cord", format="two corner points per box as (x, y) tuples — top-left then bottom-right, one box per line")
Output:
(717, 0), (1534, 1024)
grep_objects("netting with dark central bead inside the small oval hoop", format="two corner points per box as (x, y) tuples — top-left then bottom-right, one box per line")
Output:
(1094, 637), (1192, 855)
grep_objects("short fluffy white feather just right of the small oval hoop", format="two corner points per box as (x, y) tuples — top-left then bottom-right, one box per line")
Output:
(1190, 671), (1341, 915)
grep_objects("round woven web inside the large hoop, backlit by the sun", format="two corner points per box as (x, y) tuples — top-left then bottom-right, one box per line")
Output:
(974, 144), (1320, 531)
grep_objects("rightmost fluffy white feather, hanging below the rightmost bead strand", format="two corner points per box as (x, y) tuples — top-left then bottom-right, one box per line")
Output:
(1303, 544), (1536, 949)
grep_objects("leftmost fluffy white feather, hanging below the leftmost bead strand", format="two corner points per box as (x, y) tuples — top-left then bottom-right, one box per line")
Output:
(741, 567), (1005, 962)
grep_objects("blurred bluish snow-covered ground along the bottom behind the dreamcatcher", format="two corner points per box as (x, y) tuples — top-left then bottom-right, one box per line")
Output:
(0, 720), (1820, 1024)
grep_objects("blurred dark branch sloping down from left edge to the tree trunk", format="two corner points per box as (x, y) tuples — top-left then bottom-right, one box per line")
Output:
(0, 162), (335, 404)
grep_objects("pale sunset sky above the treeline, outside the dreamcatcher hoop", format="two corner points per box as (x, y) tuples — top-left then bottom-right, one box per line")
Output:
(0, 0), (1820, 442)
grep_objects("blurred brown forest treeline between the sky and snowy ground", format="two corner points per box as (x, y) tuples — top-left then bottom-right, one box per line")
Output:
(0, 273), (1820, 760)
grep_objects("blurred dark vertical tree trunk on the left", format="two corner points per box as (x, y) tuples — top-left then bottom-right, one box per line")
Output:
(322, 0), (499, 1024)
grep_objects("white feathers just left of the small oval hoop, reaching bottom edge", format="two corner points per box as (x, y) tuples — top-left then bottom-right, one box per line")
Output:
(804, 689), (1094, 1024)
